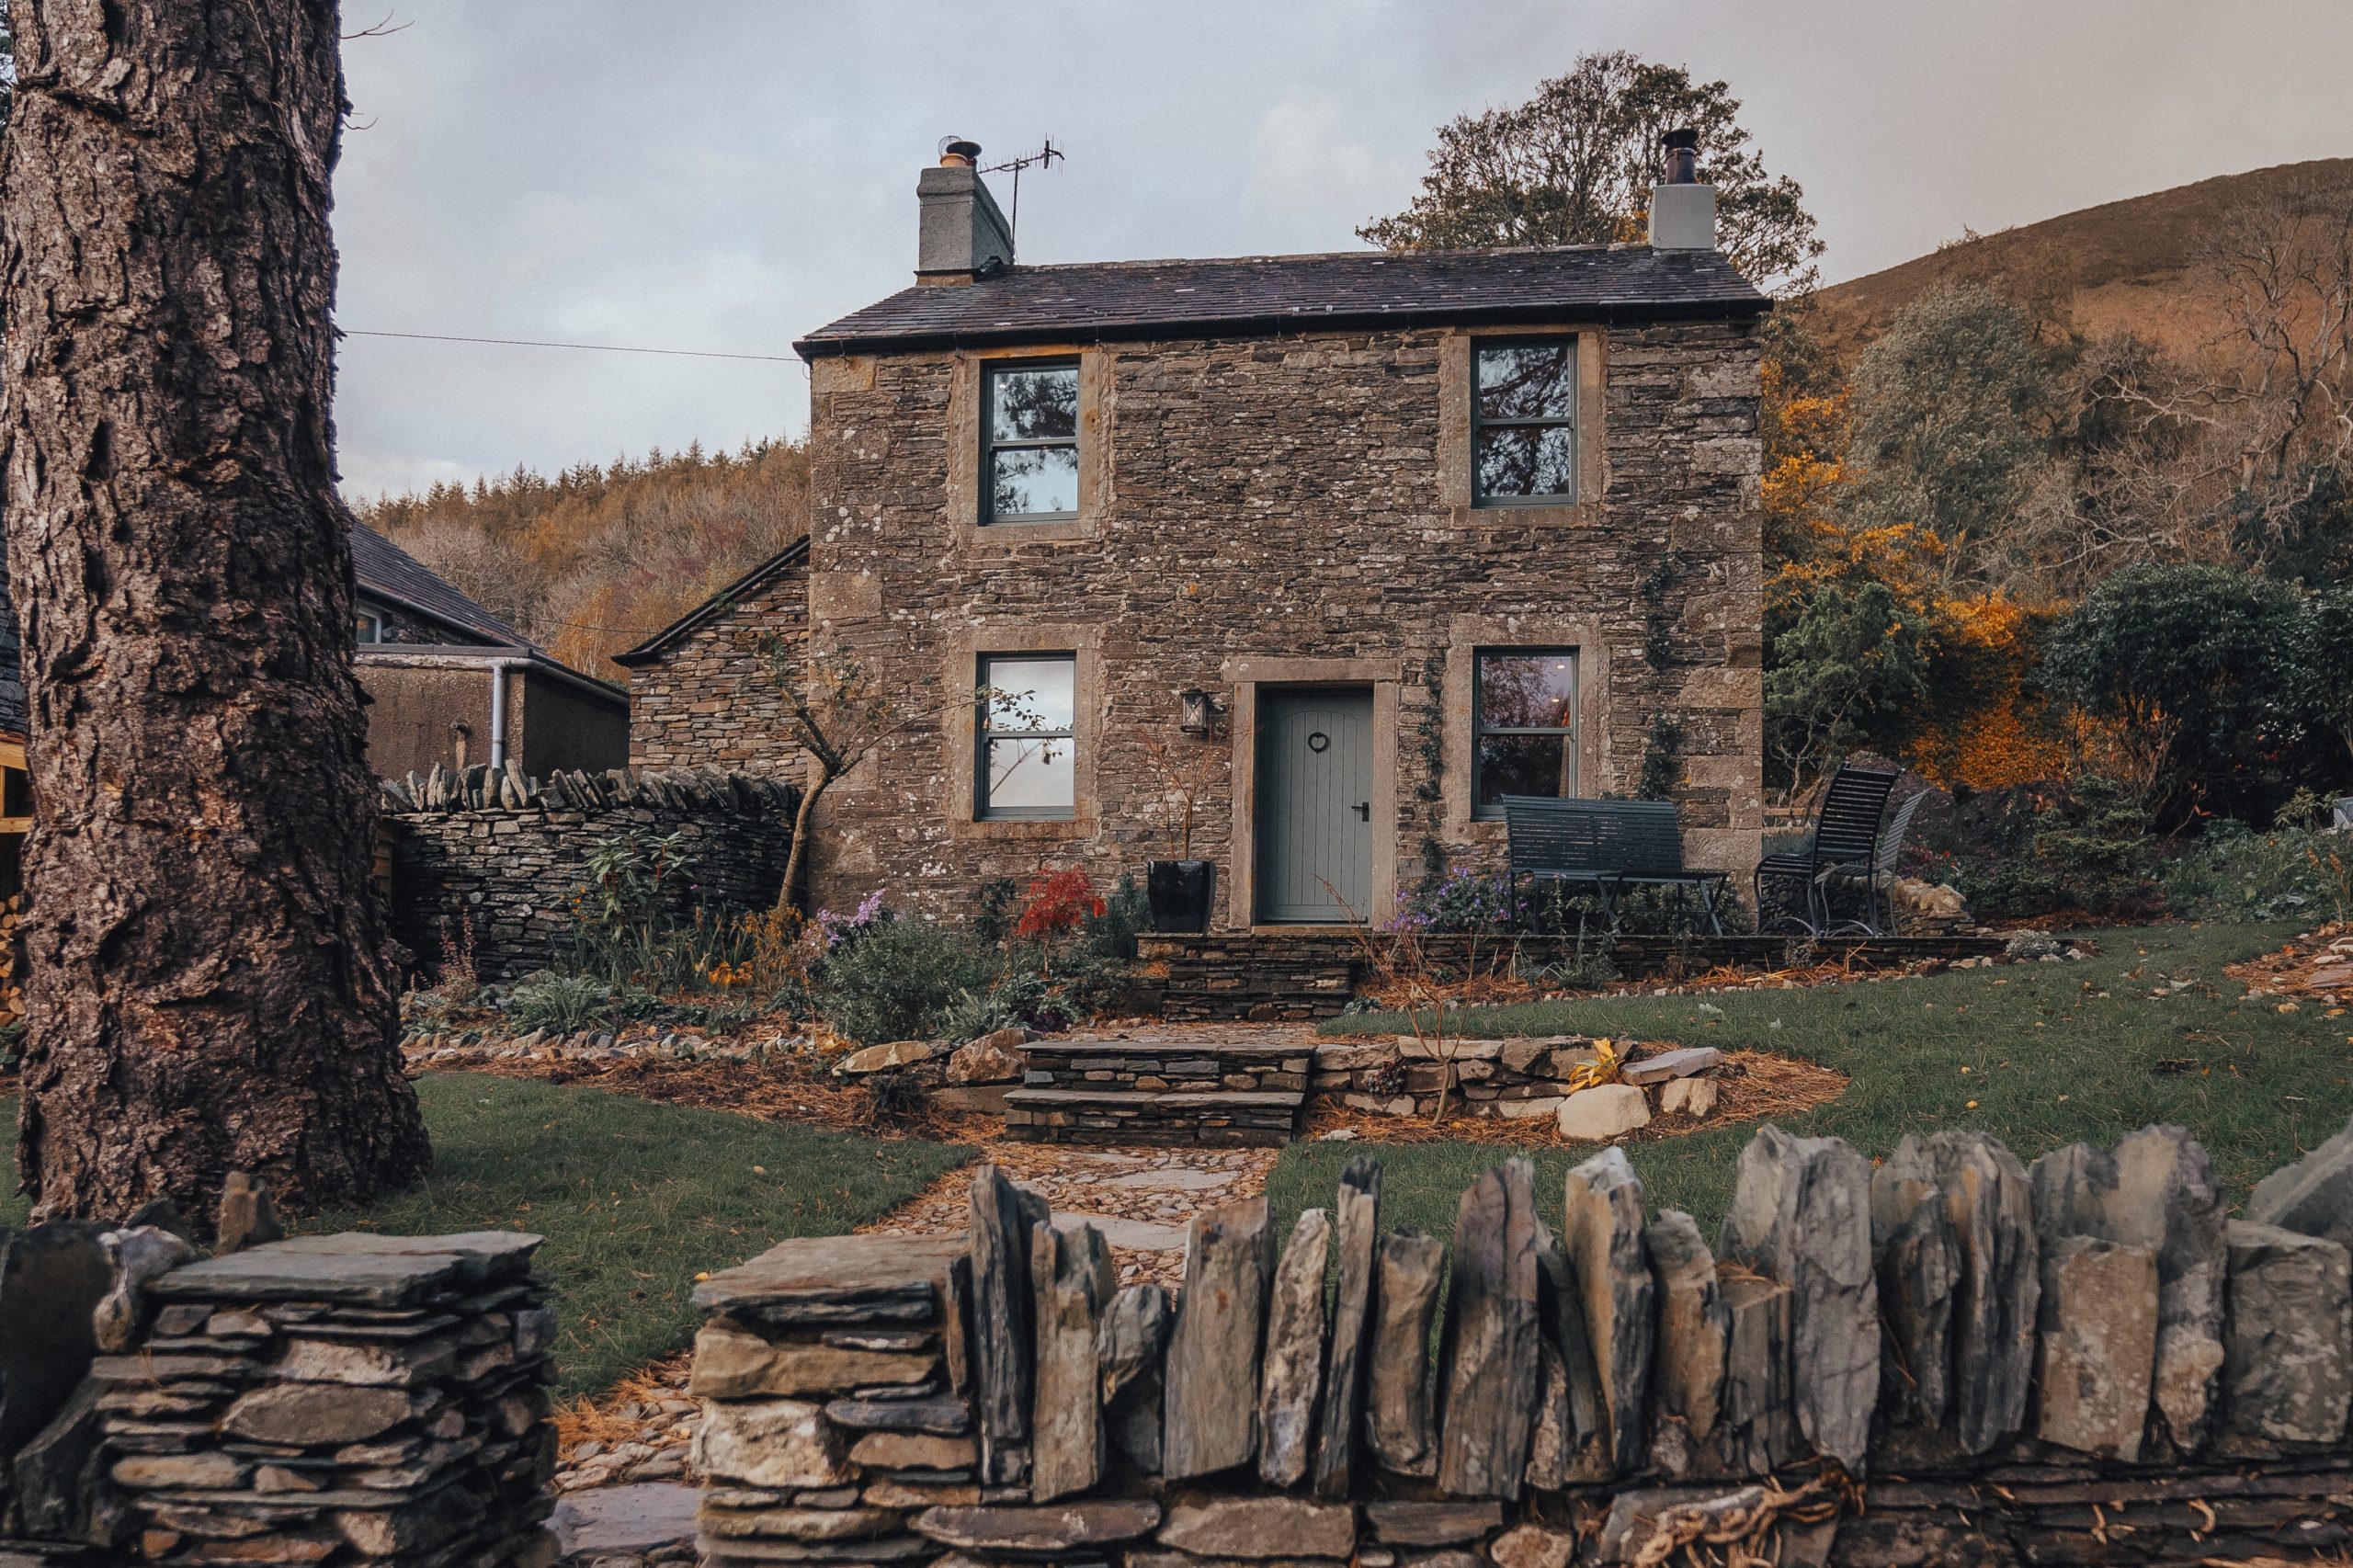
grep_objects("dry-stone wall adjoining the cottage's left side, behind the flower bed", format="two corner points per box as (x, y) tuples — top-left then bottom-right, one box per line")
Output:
(383, 766), (800, 980)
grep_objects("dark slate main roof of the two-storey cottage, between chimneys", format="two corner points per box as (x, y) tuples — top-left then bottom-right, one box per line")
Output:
(793, 244), (1772, 358)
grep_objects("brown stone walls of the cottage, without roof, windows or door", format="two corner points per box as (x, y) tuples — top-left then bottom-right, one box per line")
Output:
(633, 306), (1762, 930)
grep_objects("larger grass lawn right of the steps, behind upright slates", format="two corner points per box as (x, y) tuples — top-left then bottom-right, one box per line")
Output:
(1268, 926), (2353, 1238)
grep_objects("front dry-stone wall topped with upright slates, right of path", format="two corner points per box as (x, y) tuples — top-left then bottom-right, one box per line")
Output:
(692, 1128), (2353, 1568)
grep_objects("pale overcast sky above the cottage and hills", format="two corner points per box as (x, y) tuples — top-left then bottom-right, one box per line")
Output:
(336, 0), (2353, 494)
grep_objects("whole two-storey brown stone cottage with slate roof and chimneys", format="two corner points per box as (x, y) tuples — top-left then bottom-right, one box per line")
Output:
(621, 143), (1769, 930)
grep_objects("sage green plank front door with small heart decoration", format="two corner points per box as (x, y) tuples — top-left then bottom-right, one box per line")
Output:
(1256, 687), (1374, 923)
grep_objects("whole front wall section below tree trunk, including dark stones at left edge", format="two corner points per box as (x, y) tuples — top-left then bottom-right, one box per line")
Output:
(0, 1224), (555, 1568)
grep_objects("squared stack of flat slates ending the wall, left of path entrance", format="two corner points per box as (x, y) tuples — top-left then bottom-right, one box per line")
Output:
(89, 1232), (555, 1568)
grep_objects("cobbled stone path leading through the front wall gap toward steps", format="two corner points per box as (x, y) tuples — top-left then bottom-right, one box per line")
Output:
(555, 1142), (1276, 1506)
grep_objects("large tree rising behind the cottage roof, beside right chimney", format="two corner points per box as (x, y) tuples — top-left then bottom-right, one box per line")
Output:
(1358, 50), (1824, 294)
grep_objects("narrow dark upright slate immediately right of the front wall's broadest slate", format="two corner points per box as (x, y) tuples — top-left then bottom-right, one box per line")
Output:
(1870, 1165), (1960, 1426)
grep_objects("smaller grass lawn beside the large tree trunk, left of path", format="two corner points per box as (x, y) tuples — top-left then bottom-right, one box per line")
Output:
(0, 1074), (972, 1396)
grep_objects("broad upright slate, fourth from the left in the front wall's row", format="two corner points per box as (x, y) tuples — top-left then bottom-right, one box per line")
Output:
(1160, 1199), (1273, 1481)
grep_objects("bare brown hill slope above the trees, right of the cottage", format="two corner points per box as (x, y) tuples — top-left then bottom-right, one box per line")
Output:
(1814, 158), (2353, 353)
